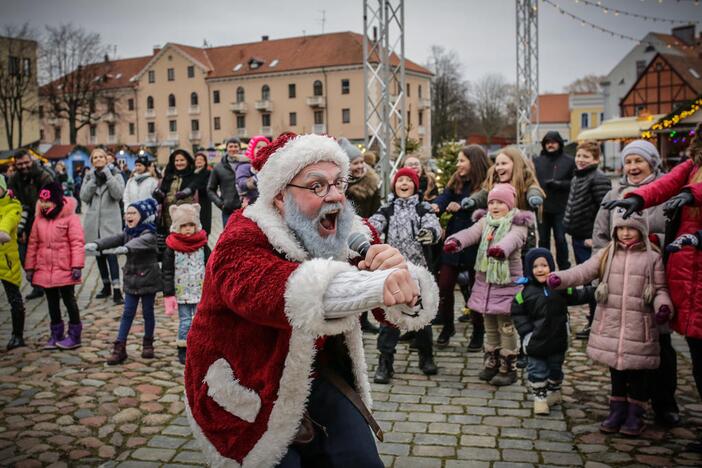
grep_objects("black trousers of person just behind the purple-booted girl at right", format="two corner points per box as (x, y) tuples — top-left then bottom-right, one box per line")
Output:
(649, 333), (680, 414)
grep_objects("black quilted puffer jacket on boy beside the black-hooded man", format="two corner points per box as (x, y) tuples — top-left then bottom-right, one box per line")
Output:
(563, 164), (612, 239)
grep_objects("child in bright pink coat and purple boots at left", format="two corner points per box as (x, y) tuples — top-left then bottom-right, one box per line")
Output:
(24, 182), (85, 349)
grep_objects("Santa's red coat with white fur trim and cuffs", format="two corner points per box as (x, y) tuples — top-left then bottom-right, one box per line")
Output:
(185, 205), (438, 467)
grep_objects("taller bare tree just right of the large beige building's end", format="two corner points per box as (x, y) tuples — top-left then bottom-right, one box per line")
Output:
(428, 46), (475, 152)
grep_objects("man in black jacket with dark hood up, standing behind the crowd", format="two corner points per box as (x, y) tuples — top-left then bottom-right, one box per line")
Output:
(534, 131), (575, 270)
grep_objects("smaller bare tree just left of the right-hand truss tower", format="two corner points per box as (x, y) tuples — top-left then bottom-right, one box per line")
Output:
(470, 73), (509, 145)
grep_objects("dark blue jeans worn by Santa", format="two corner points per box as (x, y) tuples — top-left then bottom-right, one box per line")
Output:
(278, 378), (383, 468)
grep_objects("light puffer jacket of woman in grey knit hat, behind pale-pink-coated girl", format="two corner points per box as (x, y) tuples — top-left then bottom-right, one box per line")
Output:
(592, 171), (666, 252)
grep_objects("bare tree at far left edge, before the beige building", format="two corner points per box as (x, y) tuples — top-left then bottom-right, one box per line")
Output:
(0, 23), (37, 149)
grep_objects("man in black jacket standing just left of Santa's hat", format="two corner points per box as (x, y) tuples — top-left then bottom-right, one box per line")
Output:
(207, 137), (241, 228)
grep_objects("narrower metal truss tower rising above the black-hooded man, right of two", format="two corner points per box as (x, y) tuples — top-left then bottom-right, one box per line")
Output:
(515, 0), (539, 154)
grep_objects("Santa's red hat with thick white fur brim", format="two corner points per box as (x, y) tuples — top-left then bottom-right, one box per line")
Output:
(251, 132), (349, 206)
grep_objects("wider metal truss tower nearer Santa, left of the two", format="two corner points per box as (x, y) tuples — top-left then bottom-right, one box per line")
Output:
(363, 0), (407, 196)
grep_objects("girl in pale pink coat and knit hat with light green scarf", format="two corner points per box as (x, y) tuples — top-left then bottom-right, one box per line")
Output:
(444, 183), (536, 386)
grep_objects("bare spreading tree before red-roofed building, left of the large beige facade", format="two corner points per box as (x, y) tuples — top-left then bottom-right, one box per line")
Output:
(42, 23), (113, 144)
